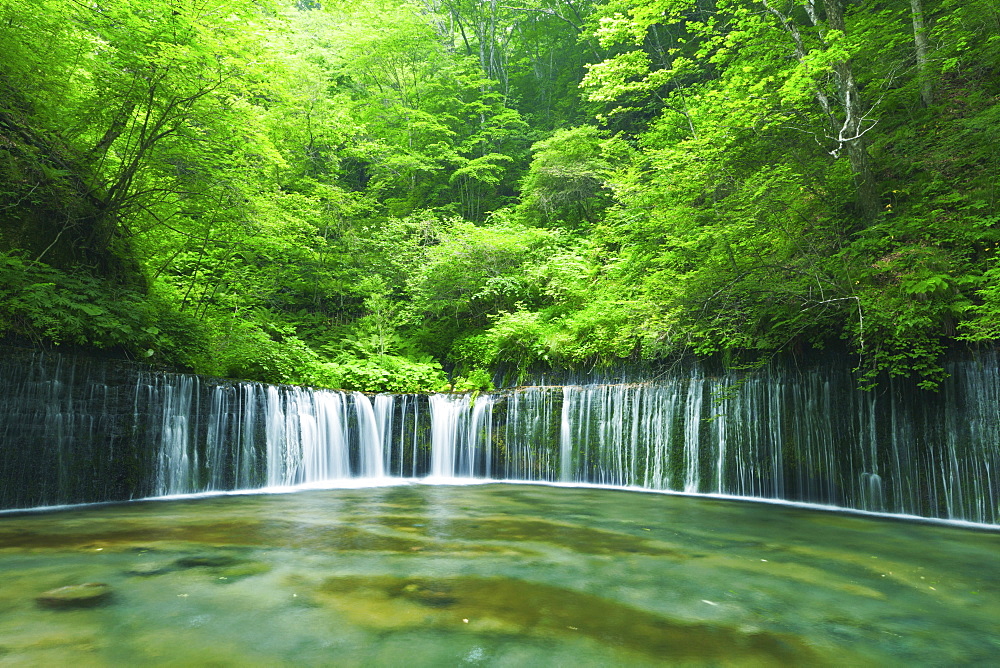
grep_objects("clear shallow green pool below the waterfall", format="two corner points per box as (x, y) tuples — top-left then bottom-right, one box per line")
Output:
(0, 484), (1000, 668)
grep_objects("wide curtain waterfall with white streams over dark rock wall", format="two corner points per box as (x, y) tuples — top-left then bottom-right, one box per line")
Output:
(0, 351), (1000, 524)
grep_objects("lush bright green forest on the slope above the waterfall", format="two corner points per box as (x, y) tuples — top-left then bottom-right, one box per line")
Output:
(0, 0), (1000, 392)
